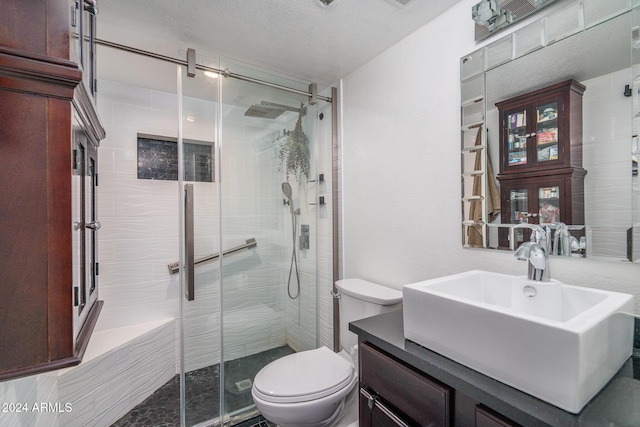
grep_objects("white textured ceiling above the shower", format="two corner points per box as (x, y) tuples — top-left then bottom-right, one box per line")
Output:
(98, 0), (460, 86)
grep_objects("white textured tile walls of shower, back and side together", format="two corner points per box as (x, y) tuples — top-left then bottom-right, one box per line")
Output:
(99, 81), (333, 369)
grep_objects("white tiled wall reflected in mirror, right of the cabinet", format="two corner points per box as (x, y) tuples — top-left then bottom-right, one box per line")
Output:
(582, 69), (633, 259)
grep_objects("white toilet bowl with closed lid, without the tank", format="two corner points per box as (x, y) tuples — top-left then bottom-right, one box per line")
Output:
(251, 347), (358, 427)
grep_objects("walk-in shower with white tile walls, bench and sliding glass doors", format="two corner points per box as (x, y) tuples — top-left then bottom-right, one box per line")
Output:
(0, 40), (337, 427)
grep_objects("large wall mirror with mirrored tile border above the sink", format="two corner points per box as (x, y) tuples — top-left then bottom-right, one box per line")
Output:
(460, 0), (640, 262)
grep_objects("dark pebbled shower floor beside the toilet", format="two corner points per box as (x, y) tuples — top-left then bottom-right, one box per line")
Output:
(112, 346), (293, 427)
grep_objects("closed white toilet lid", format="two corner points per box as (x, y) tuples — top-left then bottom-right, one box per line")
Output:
(253, 347), (355, 403)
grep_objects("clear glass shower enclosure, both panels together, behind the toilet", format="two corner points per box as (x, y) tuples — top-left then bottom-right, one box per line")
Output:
(178, 57), (319, 426)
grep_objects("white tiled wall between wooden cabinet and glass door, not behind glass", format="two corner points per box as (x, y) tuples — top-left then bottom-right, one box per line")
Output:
(98, 81), (179, 329)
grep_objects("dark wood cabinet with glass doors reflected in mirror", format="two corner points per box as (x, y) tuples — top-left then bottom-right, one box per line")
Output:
(496, 80), (587, 248)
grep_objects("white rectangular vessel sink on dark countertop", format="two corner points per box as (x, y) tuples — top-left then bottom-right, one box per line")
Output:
(403, 270), (633, 413)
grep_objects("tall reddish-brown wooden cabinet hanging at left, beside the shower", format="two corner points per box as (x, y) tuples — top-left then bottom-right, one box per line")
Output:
(0, 0), (105, 380)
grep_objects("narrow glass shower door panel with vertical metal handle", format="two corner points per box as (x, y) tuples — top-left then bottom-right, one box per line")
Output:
(178, 58), (221, 426)
